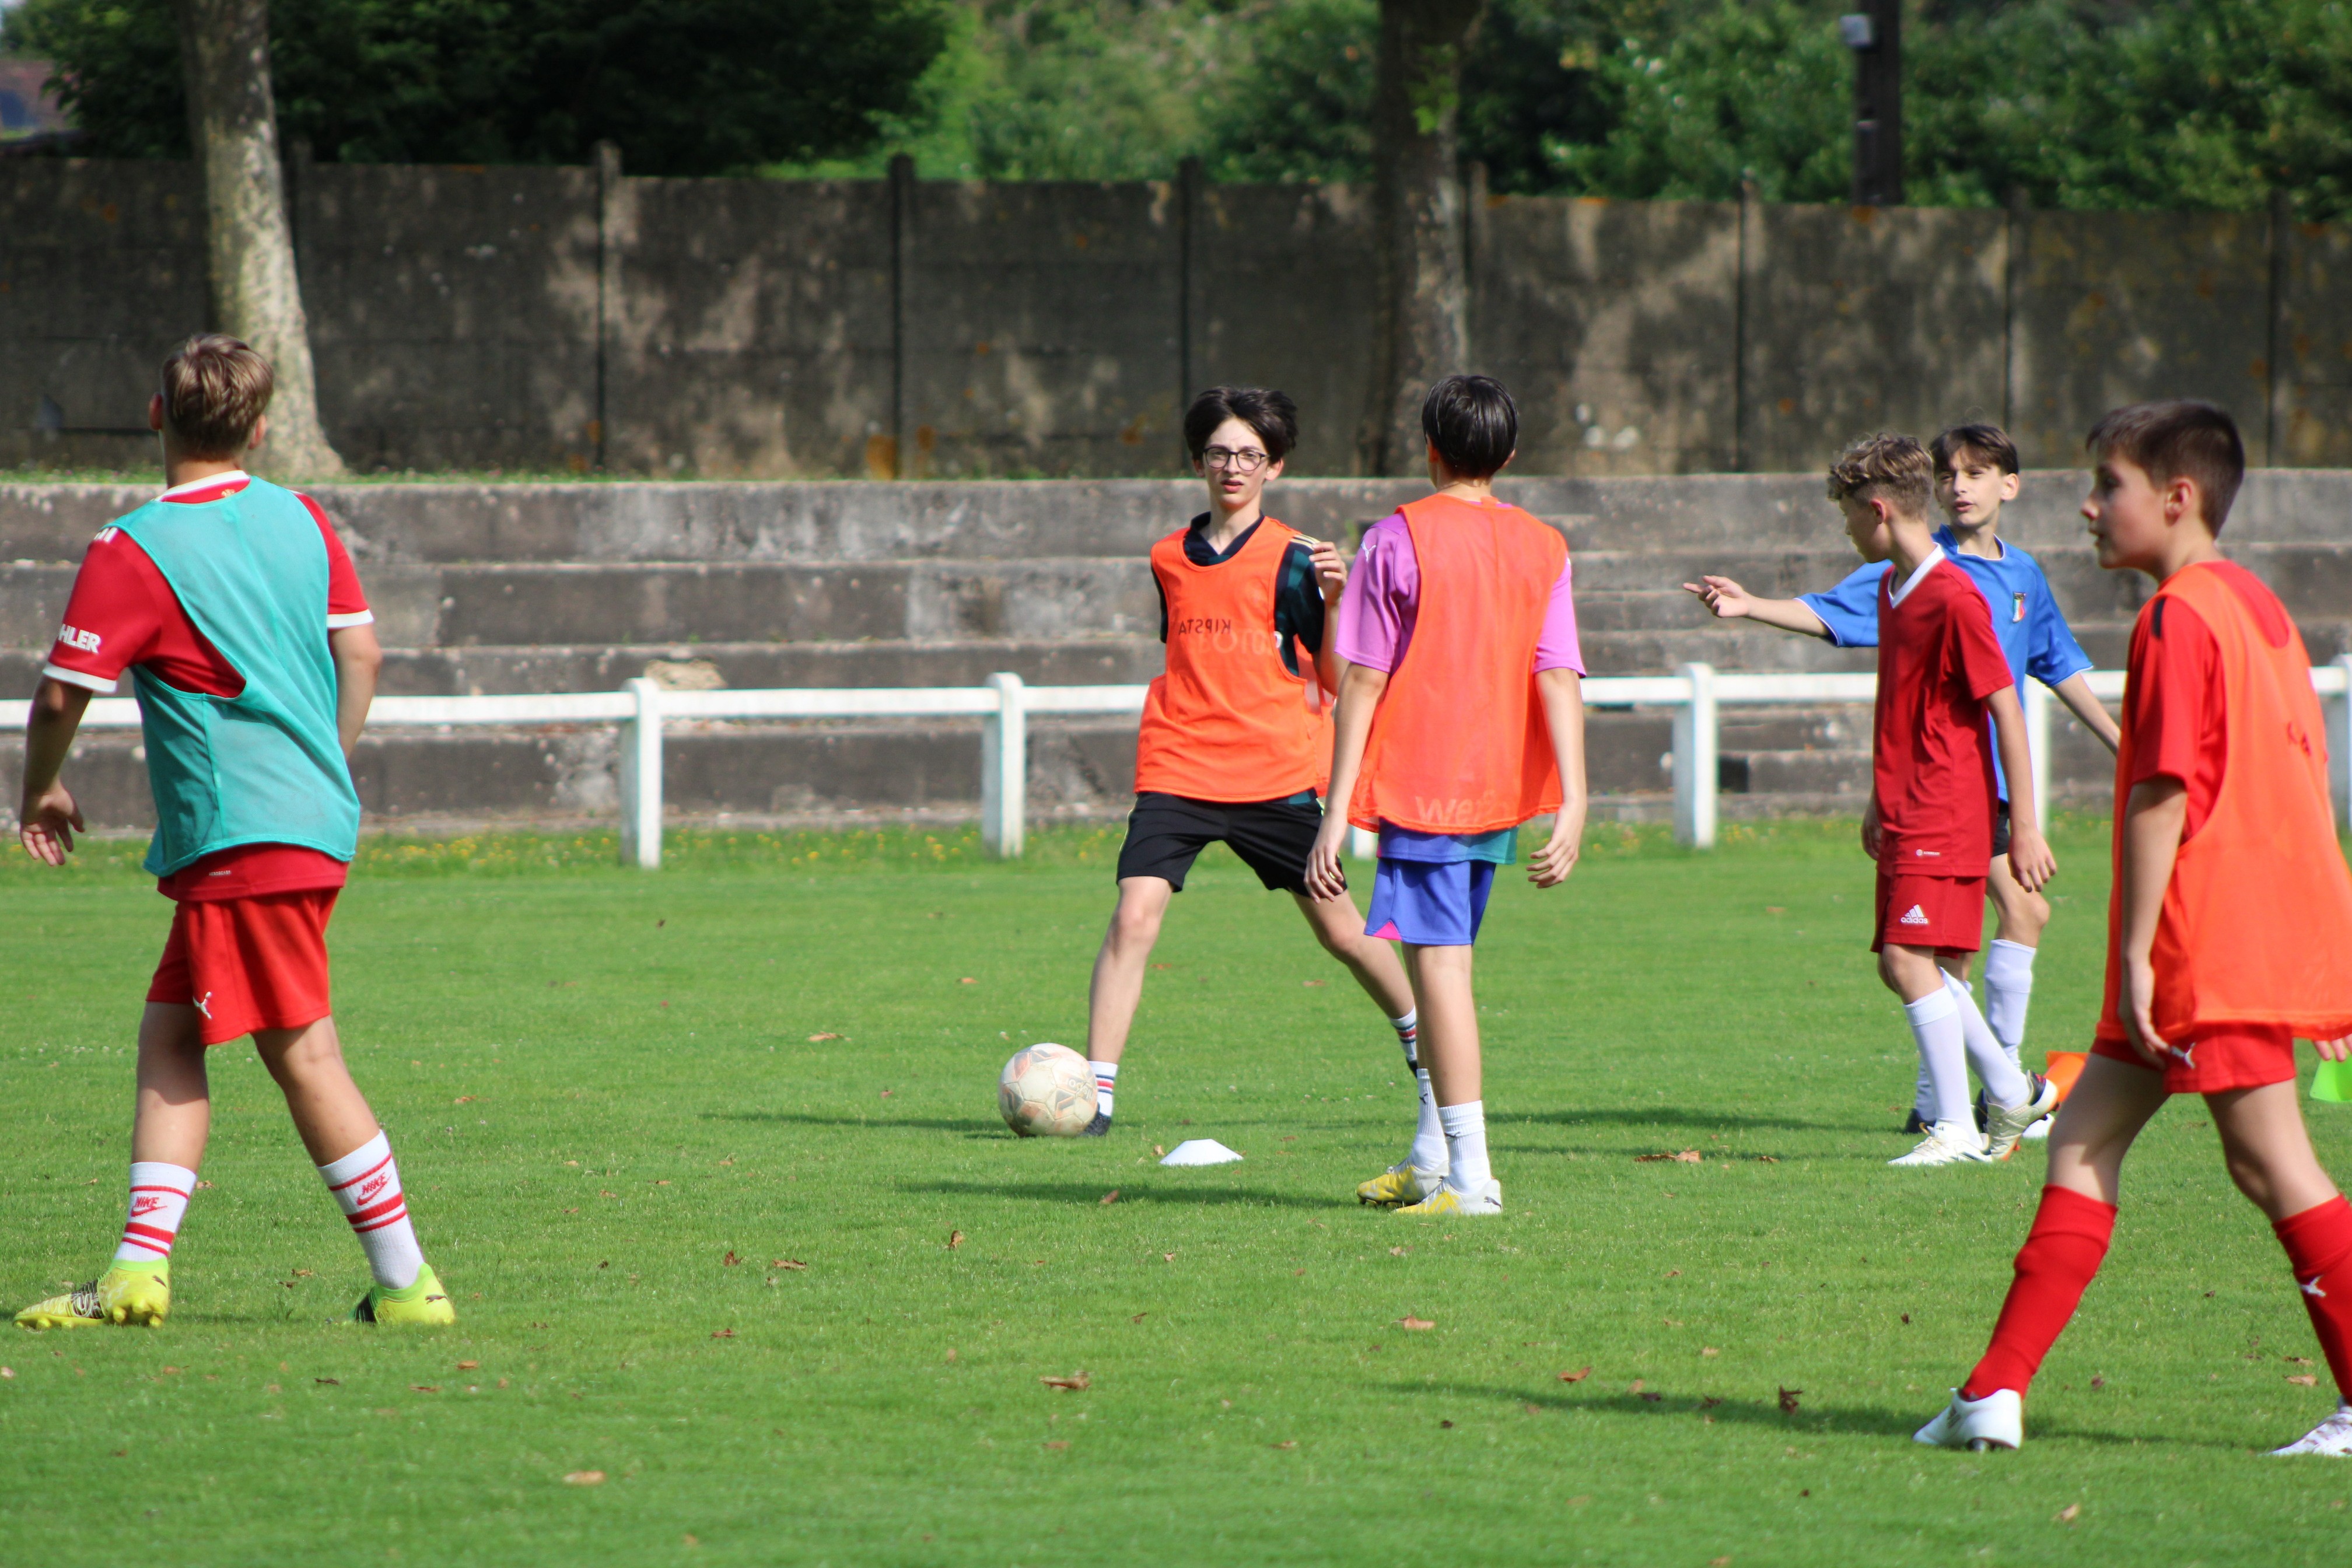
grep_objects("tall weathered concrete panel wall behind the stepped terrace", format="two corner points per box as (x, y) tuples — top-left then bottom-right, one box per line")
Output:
(0, 160), (2352, 477)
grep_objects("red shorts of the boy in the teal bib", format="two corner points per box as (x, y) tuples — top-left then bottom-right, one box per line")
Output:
(148, 888), (341, 1046)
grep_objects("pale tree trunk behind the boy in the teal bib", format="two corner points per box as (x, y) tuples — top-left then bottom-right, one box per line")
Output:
(174, 0), (344, 477)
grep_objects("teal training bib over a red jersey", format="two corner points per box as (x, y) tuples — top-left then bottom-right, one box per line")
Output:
(116, 480), (360, 877)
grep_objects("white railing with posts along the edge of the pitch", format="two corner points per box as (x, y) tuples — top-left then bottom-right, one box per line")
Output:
(18, 653), (2352, 870)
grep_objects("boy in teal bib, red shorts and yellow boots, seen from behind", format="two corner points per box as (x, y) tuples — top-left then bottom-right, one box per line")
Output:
(16, 336), (456, 1328)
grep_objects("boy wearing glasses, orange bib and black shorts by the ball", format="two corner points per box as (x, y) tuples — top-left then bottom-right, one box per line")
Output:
(1087, 386), (1444, 1147)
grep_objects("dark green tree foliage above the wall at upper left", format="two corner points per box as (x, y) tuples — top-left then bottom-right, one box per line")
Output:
(7, 0), (946, 174)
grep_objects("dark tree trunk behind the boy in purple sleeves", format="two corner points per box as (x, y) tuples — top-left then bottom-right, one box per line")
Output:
(1364, 0), (1486, 475)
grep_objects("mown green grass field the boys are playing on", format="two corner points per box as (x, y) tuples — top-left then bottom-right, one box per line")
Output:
(0, 822), (2352, 1568)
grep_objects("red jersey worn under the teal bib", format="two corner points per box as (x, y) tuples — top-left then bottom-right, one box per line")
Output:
(40, 473), (376, 903)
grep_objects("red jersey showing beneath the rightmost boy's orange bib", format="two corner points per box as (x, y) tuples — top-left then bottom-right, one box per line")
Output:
(2124, 562), (2293, 839)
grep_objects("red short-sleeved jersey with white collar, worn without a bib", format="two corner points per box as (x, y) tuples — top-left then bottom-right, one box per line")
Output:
(1870, 550), (2015, 877)
